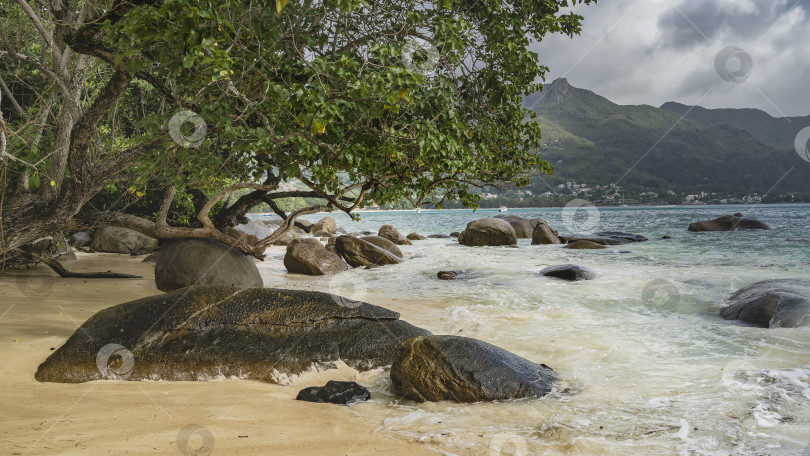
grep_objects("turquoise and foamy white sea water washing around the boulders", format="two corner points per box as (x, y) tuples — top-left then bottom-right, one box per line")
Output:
(254, 205), (810, 456)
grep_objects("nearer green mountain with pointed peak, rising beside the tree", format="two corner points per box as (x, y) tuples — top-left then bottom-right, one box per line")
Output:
(525, 79), (810, 194)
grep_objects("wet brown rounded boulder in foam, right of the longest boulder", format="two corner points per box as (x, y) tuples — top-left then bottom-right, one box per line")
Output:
(391, 336), (558, 402)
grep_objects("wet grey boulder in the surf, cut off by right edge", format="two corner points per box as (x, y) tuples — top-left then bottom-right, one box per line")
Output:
(720, 279), (810, 328)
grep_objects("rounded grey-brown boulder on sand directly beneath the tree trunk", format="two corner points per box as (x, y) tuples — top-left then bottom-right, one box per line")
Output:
(155, 239), (264, 291)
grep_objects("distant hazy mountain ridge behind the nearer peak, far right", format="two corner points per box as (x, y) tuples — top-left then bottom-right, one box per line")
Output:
(661, 102), (810, 149)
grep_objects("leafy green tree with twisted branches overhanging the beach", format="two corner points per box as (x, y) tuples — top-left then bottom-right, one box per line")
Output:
(0, 0), (590, 264)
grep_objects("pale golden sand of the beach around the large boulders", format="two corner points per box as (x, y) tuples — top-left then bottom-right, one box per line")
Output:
(0, 253), (436, 456)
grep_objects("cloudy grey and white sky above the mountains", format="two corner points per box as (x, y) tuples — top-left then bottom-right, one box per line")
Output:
(533, 0), (810, 117)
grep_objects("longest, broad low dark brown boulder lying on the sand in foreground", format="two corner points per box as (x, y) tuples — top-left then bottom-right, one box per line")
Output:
(35, 285), (430, 383)
